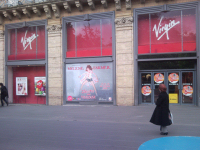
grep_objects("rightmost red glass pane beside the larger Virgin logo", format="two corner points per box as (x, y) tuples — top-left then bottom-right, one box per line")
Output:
(182, 9), (196, 51)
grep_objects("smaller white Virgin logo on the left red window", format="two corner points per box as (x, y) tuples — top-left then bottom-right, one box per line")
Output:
(21, 30), (39, 50)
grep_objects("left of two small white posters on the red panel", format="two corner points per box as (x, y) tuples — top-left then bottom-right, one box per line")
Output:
(16, 77), (28, 95)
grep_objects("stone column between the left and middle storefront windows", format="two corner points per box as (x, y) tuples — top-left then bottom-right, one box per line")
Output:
(47, 24), (63, 105)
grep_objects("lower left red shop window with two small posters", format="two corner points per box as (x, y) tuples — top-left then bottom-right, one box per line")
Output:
(12, 66), (46, 104)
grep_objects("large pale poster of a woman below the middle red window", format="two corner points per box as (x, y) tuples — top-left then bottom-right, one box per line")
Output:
(66, 63), (113, 101)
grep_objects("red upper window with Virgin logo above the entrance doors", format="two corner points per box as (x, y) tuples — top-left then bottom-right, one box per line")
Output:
(138, 9), (196, 54)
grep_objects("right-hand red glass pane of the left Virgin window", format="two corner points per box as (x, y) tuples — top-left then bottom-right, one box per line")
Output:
(37, 26), (45, 59)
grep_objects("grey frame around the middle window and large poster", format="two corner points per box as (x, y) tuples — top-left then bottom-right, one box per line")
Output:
(62, 11), (116, 105)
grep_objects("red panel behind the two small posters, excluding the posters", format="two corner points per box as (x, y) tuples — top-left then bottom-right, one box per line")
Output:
(13, 66), (46, 104)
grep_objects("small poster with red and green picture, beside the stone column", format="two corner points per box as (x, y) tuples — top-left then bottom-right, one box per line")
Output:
(34, 77), (46, 96)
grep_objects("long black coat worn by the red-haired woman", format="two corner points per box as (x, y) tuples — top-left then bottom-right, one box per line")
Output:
(150, 92), (171, 126)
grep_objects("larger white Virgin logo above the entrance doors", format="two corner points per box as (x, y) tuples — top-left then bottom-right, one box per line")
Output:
(153, 16), (180, 40)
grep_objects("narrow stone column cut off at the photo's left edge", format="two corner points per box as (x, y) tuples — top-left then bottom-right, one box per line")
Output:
(0, 30), (5, 83)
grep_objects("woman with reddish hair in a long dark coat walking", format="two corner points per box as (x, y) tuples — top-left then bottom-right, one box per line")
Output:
(150, 84), (171, 135)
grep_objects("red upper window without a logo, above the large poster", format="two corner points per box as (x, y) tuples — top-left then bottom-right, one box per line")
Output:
(66, 19), (112, 58)
